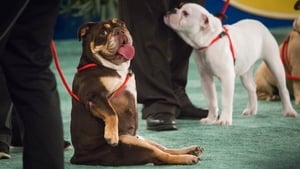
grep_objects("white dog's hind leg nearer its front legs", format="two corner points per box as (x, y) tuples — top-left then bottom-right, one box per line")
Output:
(240, 69), (257, 115)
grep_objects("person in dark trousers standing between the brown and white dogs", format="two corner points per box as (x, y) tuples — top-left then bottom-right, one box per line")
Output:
(118, 0), (208, 131)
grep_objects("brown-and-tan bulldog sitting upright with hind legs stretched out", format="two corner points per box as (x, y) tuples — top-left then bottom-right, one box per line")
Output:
(71, 19), (202, 165)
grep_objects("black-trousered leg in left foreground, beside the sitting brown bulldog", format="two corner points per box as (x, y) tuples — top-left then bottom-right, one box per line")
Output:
(0, 0), (64, 169)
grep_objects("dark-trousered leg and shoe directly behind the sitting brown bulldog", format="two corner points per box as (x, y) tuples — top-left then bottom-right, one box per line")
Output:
(119, 0), (179, 130)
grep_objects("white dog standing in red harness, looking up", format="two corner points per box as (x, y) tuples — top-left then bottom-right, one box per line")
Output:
(164, 3), (297, 125)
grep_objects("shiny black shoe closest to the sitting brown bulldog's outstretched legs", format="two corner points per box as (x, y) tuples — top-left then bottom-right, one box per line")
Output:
(147, 113), (177, 131)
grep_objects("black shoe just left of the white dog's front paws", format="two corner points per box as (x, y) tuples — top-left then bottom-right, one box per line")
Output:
(177, 104), (208, 120)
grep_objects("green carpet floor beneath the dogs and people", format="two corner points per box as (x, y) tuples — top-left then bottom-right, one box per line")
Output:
(0, 29), (300, 169)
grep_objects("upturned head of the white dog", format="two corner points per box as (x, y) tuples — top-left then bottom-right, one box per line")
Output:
(164, 3), (210, 33)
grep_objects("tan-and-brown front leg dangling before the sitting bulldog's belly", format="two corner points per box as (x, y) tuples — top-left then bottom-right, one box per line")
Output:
(89, 101), (119, 146)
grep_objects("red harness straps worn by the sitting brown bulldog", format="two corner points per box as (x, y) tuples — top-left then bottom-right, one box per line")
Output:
(75, 63), (132, 101)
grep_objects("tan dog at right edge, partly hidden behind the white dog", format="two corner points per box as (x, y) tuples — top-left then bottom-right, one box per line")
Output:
(255, 16), (300, 104)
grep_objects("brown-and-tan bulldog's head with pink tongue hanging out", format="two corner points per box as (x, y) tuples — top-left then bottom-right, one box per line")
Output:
(78, 18), (134, 65)
